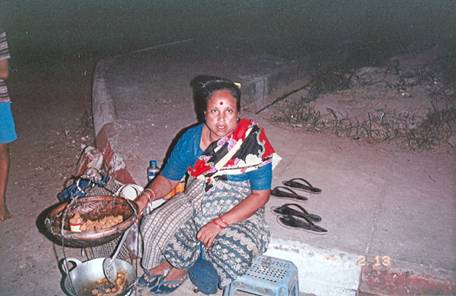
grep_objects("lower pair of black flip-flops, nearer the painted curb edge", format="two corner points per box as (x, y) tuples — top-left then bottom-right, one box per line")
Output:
(271, 203), (328, 234)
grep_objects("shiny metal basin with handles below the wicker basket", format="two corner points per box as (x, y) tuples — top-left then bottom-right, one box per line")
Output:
(60, 258), (136, 296)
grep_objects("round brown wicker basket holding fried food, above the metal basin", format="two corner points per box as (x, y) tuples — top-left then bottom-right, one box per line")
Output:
(44, 195), (137, 248)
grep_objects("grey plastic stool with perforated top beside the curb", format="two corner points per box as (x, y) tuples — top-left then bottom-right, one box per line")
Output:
(223, 256), (299, 296)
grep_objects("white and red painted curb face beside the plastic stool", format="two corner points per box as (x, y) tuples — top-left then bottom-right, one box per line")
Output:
(266, 239), (456, 296)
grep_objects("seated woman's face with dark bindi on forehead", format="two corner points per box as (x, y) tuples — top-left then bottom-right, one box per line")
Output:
(205, 90), (239, 140)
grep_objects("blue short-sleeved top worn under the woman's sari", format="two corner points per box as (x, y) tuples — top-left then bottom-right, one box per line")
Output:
(161, 123), (272, 190)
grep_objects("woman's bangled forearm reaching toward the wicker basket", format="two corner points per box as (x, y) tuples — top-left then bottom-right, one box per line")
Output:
(135, 175), (178, 213)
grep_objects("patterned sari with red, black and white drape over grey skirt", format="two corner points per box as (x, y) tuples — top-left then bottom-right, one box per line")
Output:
(141, 119), (278, 287)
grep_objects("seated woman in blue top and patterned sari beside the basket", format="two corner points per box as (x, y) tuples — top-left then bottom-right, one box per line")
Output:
(137, 77), (276, 294)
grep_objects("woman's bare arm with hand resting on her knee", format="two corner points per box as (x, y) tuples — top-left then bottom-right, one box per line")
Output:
(196, 190), (271, 249)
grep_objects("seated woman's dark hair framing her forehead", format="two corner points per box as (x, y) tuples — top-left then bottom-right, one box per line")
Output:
(190, 75), (241, 119)
